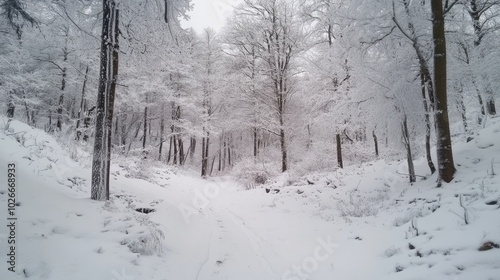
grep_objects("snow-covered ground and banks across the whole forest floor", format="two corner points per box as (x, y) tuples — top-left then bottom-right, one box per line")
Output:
(0, 115), (500, 280)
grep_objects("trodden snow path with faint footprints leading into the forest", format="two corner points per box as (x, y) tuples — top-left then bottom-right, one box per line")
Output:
(197, 178), (280, 280)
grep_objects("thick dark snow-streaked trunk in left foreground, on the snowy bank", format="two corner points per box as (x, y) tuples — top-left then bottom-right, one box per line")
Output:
(91, 0), (119, 200)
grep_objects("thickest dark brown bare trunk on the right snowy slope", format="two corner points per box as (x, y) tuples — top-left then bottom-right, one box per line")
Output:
(431, 0), (455, 183)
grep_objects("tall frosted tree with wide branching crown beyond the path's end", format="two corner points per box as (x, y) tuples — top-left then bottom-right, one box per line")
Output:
(228, 0), (306, 172)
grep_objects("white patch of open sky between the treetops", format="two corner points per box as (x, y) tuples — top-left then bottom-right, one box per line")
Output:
(182, 0), (240, 33)
